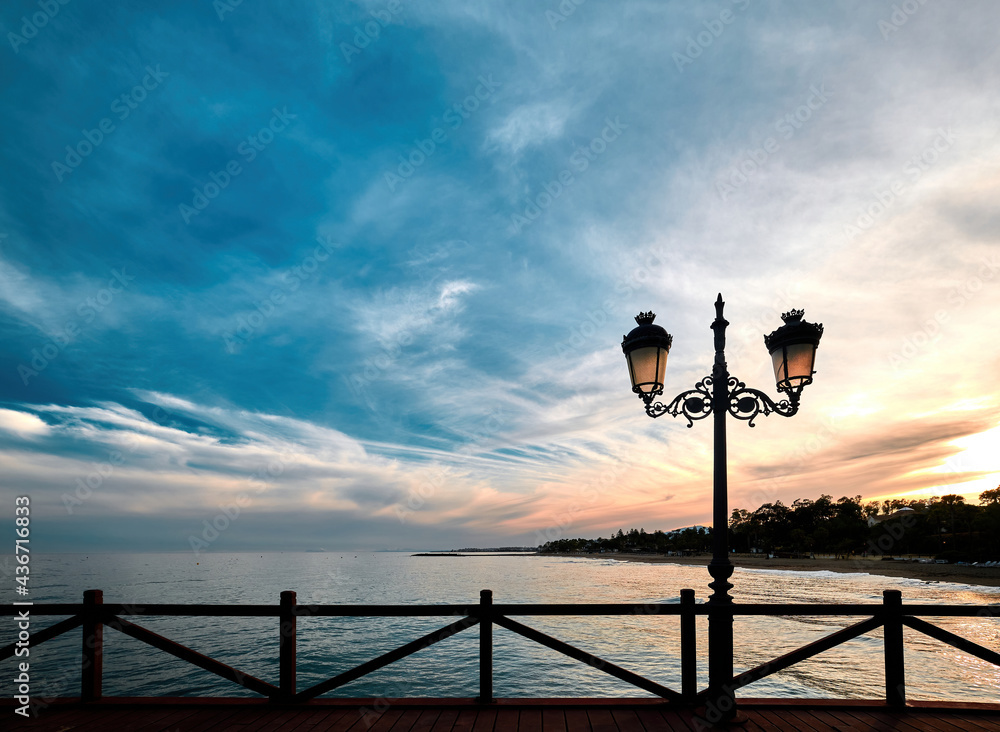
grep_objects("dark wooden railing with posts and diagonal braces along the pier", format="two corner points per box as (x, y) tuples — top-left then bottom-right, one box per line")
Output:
(0, 590), (1000, 706)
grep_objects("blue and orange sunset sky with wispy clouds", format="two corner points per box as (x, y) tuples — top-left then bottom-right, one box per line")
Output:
(0, 0), (1000, 554)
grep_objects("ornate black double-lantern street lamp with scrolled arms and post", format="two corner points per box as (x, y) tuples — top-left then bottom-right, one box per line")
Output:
(622, 294), (823, 718)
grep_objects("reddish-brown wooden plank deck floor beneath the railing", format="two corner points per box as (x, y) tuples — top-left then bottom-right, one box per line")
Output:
(7, 699), (1000, 732)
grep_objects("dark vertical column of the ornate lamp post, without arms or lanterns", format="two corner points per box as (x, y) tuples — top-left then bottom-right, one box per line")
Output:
(708, 294), (736, 718)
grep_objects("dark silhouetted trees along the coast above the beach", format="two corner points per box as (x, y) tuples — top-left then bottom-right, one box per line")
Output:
(539, 487), (1000, 562)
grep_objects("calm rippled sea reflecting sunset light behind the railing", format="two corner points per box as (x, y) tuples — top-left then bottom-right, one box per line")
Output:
(9, 553), (1000, 701)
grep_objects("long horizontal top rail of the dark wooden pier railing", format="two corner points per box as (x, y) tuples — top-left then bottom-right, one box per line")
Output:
(0, 603), (1000, 618)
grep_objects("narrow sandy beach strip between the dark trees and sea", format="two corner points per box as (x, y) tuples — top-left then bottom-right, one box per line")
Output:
(537, 553), (1000, 587)
